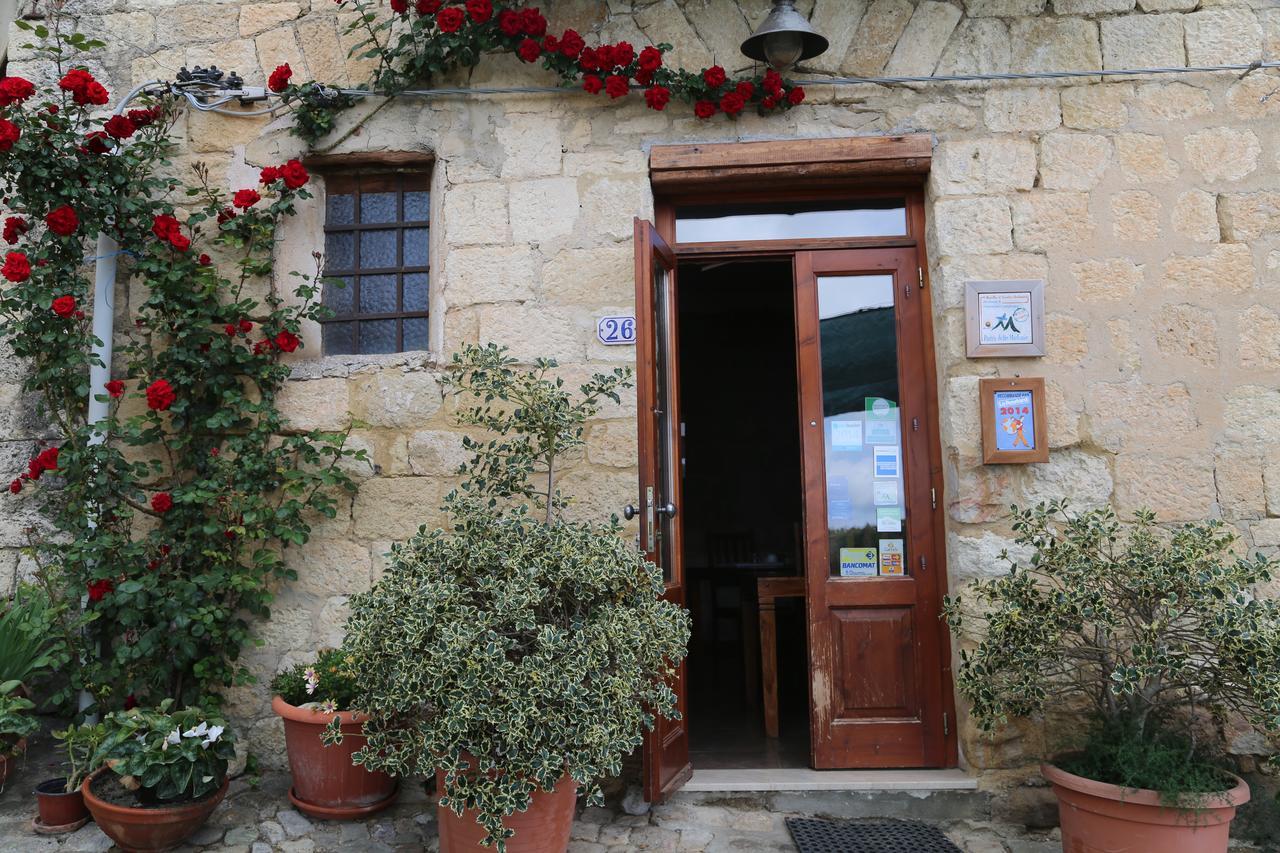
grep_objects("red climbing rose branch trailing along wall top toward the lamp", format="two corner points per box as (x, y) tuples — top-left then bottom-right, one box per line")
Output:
(275, 0), (805, 142)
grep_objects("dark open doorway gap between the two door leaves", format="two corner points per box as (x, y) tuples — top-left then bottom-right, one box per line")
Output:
(678, 259), (809, 768)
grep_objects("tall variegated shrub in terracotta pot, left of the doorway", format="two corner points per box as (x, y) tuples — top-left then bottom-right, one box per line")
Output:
(326, 345), (689, 853)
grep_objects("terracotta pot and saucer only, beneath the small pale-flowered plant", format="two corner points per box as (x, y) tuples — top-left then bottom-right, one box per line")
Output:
(271, 697), (399, 820)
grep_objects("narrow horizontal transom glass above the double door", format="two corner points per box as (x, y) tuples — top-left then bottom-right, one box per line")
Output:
(676, 199), (906, 243)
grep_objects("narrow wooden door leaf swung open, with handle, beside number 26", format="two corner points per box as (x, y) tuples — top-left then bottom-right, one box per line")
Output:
(635, 219), (694, 803)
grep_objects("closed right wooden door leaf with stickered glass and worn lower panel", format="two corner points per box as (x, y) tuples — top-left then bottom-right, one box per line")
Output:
(795, 248), (948, 768)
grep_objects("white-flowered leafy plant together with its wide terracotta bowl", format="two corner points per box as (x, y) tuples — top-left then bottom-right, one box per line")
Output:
(81, 699), (236, 852)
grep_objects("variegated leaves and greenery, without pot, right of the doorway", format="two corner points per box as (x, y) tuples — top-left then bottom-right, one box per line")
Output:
(945, 502), (1280, 793)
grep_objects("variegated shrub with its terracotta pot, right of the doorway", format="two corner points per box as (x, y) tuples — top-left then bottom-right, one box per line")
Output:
(946, 502), (1280, 853)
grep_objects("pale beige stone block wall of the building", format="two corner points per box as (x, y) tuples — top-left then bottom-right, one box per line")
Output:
(0, 0), (1280, 767)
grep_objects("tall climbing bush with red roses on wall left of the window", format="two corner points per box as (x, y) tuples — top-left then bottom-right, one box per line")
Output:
(0, 22), (365, 711)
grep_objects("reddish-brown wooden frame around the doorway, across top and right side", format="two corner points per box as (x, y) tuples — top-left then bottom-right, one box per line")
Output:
(653, 171), (960, 767)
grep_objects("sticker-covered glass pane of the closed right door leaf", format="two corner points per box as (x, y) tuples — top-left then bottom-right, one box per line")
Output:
(818, 275), (909, 578)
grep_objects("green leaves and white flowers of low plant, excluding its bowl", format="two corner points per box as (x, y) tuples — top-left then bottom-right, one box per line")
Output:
(95, 699), (236, 803)
